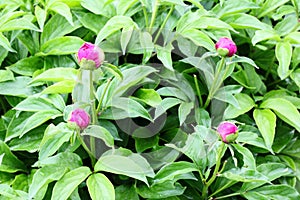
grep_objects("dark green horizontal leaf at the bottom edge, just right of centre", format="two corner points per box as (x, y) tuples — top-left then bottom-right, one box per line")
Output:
(137, 181), (185, 199)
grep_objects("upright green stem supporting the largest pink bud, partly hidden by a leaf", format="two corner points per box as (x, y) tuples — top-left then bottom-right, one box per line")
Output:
(90, 70), (97, 166)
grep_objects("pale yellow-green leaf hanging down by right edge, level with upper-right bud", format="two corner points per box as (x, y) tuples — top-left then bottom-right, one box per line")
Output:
(275, 42), (292, 80)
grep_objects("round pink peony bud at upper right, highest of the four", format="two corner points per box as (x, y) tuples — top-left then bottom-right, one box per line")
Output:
(215, 37), (237, 57)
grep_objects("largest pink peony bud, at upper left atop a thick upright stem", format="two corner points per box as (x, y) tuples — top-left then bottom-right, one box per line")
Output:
(78, 42), (104, 68)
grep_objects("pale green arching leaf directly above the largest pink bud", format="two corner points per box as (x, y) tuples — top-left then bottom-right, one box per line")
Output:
(95, 16), (137, 45)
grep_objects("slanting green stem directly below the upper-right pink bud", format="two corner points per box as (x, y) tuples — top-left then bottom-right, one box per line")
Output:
(204, 57), (226, 109)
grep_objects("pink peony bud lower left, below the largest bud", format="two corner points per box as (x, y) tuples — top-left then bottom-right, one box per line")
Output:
(69, 108), (90, 130)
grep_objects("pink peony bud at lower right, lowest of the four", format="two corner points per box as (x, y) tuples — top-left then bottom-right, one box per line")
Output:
(217, 122), (238, 143)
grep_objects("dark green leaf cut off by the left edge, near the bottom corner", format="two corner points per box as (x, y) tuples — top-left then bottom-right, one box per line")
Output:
(0, 140), (25, 173)
